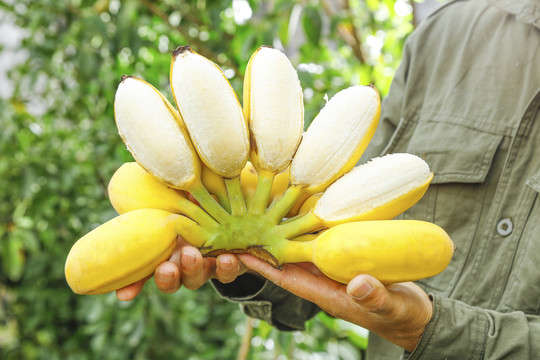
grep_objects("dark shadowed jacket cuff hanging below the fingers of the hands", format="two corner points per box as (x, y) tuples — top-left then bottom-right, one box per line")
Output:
(212, 273), (320, 331)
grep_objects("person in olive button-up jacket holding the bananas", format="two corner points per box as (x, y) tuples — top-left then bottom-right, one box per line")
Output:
(117, 0), (540, 360)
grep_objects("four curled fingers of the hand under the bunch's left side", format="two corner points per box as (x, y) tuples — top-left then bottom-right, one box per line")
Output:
(116, 237), (247, 301)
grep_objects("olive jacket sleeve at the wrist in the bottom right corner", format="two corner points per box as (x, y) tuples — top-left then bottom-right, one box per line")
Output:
(408, 296), (540, 360)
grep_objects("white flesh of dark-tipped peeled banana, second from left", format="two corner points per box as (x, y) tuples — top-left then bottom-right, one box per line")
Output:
(171, 46), (249, 178)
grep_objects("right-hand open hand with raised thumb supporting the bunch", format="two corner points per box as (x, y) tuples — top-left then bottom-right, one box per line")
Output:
(239, 255), (433, 351)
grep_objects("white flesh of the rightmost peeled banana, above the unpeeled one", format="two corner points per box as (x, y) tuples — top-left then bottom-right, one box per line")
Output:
(313, 153), (431, 221)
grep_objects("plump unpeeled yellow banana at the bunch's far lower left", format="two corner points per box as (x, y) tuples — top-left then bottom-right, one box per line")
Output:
(65, 209), (179, 294)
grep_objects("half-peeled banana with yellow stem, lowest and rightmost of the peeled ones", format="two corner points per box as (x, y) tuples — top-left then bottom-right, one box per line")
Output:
(279, 154), (433, 238)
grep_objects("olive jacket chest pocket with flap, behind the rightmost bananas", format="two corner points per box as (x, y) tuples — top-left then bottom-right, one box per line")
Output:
(386, 116), (503, 295)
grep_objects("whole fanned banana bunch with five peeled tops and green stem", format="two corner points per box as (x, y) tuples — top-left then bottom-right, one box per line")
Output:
(65, 46), (454, 294)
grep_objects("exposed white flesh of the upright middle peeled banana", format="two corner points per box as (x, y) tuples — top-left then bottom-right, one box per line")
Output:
(244, 47), (304, 173)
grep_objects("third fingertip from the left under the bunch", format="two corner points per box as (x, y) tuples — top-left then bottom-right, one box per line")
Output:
(180, 246), (212, 290)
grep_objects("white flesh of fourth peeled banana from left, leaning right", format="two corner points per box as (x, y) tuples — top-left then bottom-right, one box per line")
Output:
(291, 86), (380, 190)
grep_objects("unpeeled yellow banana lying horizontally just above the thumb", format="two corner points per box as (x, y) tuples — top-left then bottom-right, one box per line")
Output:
(278, 220), (454, 284)
